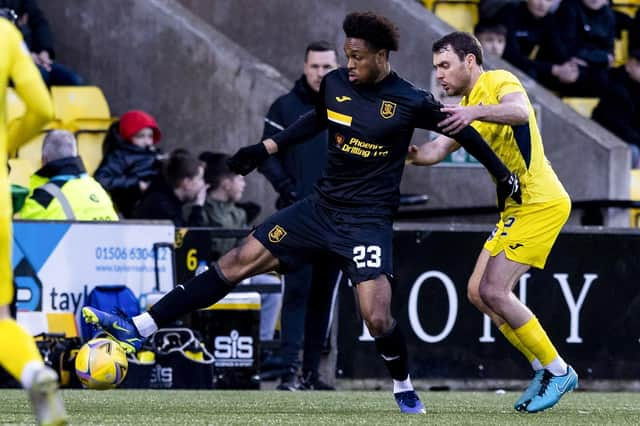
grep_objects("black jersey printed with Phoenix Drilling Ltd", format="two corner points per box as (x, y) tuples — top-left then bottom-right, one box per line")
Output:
(316, 68), (444, 216)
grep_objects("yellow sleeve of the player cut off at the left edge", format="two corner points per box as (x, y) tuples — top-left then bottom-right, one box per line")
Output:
(5, 25), (53, 153)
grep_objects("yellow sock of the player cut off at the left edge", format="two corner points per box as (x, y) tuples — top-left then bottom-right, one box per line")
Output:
(0, 319), (42, 381)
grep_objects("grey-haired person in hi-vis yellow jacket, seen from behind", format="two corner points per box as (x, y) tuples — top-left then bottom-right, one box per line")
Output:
(19, 130), (118, 220)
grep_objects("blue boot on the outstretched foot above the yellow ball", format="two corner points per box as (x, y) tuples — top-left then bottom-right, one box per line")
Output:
(82, 306), (144, 354)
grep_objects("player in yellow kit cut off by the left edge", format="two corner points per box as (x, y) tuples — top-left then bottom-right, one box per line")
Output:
(0, 17), (67, 425)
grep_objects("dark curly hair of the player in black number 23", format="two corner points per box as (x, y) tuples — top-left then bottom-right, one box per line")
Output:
(342, 12), (400, 51)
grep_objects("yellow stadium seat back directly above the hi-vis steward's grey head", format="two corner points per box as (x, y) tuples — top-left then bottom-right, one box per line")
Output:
(51, 86), (111, 132)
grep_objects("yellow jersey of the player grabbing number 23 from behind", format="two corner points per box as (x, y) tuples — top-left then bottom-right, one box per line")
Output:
(460, 70), (568, 204)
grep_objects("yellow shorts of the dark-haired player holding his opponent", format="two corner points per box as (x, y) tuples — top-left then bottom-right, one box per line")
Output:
(484, 197), (571, 269)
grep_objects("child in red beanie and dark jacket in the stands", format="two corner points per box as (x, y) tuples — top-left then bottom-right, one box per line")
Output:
(94, 110), (161, 218)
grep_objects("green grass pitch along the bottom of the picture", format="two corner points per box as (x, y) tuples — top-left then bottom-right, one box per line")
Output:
(0, 389), (640, 426)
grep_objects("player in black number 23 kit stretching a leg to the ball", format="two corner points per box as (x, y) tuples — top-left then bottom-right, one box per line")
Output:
(83, 12), (520, 413)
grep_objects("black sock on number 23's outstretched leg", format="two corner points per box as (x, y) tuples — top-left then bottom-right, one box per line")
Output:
(149, 264), (235, 327)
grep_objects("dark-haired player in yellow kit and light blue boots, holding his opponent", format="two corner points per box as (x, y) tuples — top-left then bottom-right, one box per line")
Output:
(408, 32), (578, 412)
